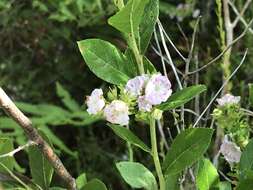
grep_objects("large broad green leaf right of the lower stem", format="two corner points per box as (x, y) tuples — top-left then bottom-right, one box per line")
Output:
(163, 128), (213, 175)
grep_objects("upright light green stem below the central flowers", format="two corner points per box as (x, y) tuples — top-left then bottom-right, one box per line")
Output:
(150, 116), (165, 190)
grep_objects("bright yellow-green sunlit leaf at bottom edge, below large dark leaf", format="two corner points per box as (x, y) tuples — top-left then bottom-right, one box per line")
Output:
(196, 159), (219, 190)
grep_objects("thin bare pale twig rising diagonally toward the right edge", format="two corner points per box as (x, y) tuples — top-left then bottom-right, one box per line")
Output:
(193, 50), (248, 128)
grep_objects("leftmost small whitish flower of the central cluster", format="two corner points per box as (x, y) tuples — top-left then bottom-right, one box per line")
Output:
(86, 89), (105, 114)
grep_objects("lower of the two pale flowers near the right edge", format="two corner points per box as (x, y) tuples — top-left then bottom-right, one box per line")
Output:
(220, 135), (242, 164)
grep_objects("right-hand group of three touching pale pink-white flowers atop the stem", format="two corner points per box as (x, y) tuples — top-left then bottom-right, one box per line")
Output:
(125, 73), (172, 112)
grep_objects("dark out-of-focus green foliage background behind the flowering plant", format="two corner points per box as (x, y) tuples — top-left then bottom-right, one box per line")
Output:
(0, 0), (253, 189)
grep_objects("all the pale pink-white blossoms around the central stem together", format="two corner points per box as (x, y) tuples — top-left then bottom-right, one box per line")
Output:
(86, 73), (172, 125)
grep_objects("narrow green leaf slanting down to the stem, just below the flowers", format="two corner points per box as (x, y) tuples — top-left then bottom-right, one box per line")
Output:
(109, 125), (151, 153)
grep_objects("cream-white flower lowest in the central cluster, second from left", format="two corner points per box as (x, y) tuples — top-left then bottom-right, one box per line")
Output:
(104, 100), (129, 125)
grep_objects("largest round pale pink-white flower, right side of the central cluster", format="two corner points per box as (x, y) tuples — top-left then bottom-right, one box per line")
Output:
(145, 73), (172, 105)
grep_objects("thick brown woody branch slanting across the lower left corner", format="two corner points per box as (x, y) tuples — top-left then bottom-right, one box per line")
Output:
(0, 87), (76, 190)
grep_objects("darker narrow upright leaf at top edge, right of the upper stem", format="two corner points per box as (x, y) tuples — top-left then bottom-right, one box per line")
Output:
(140, 0), (159, 55)
